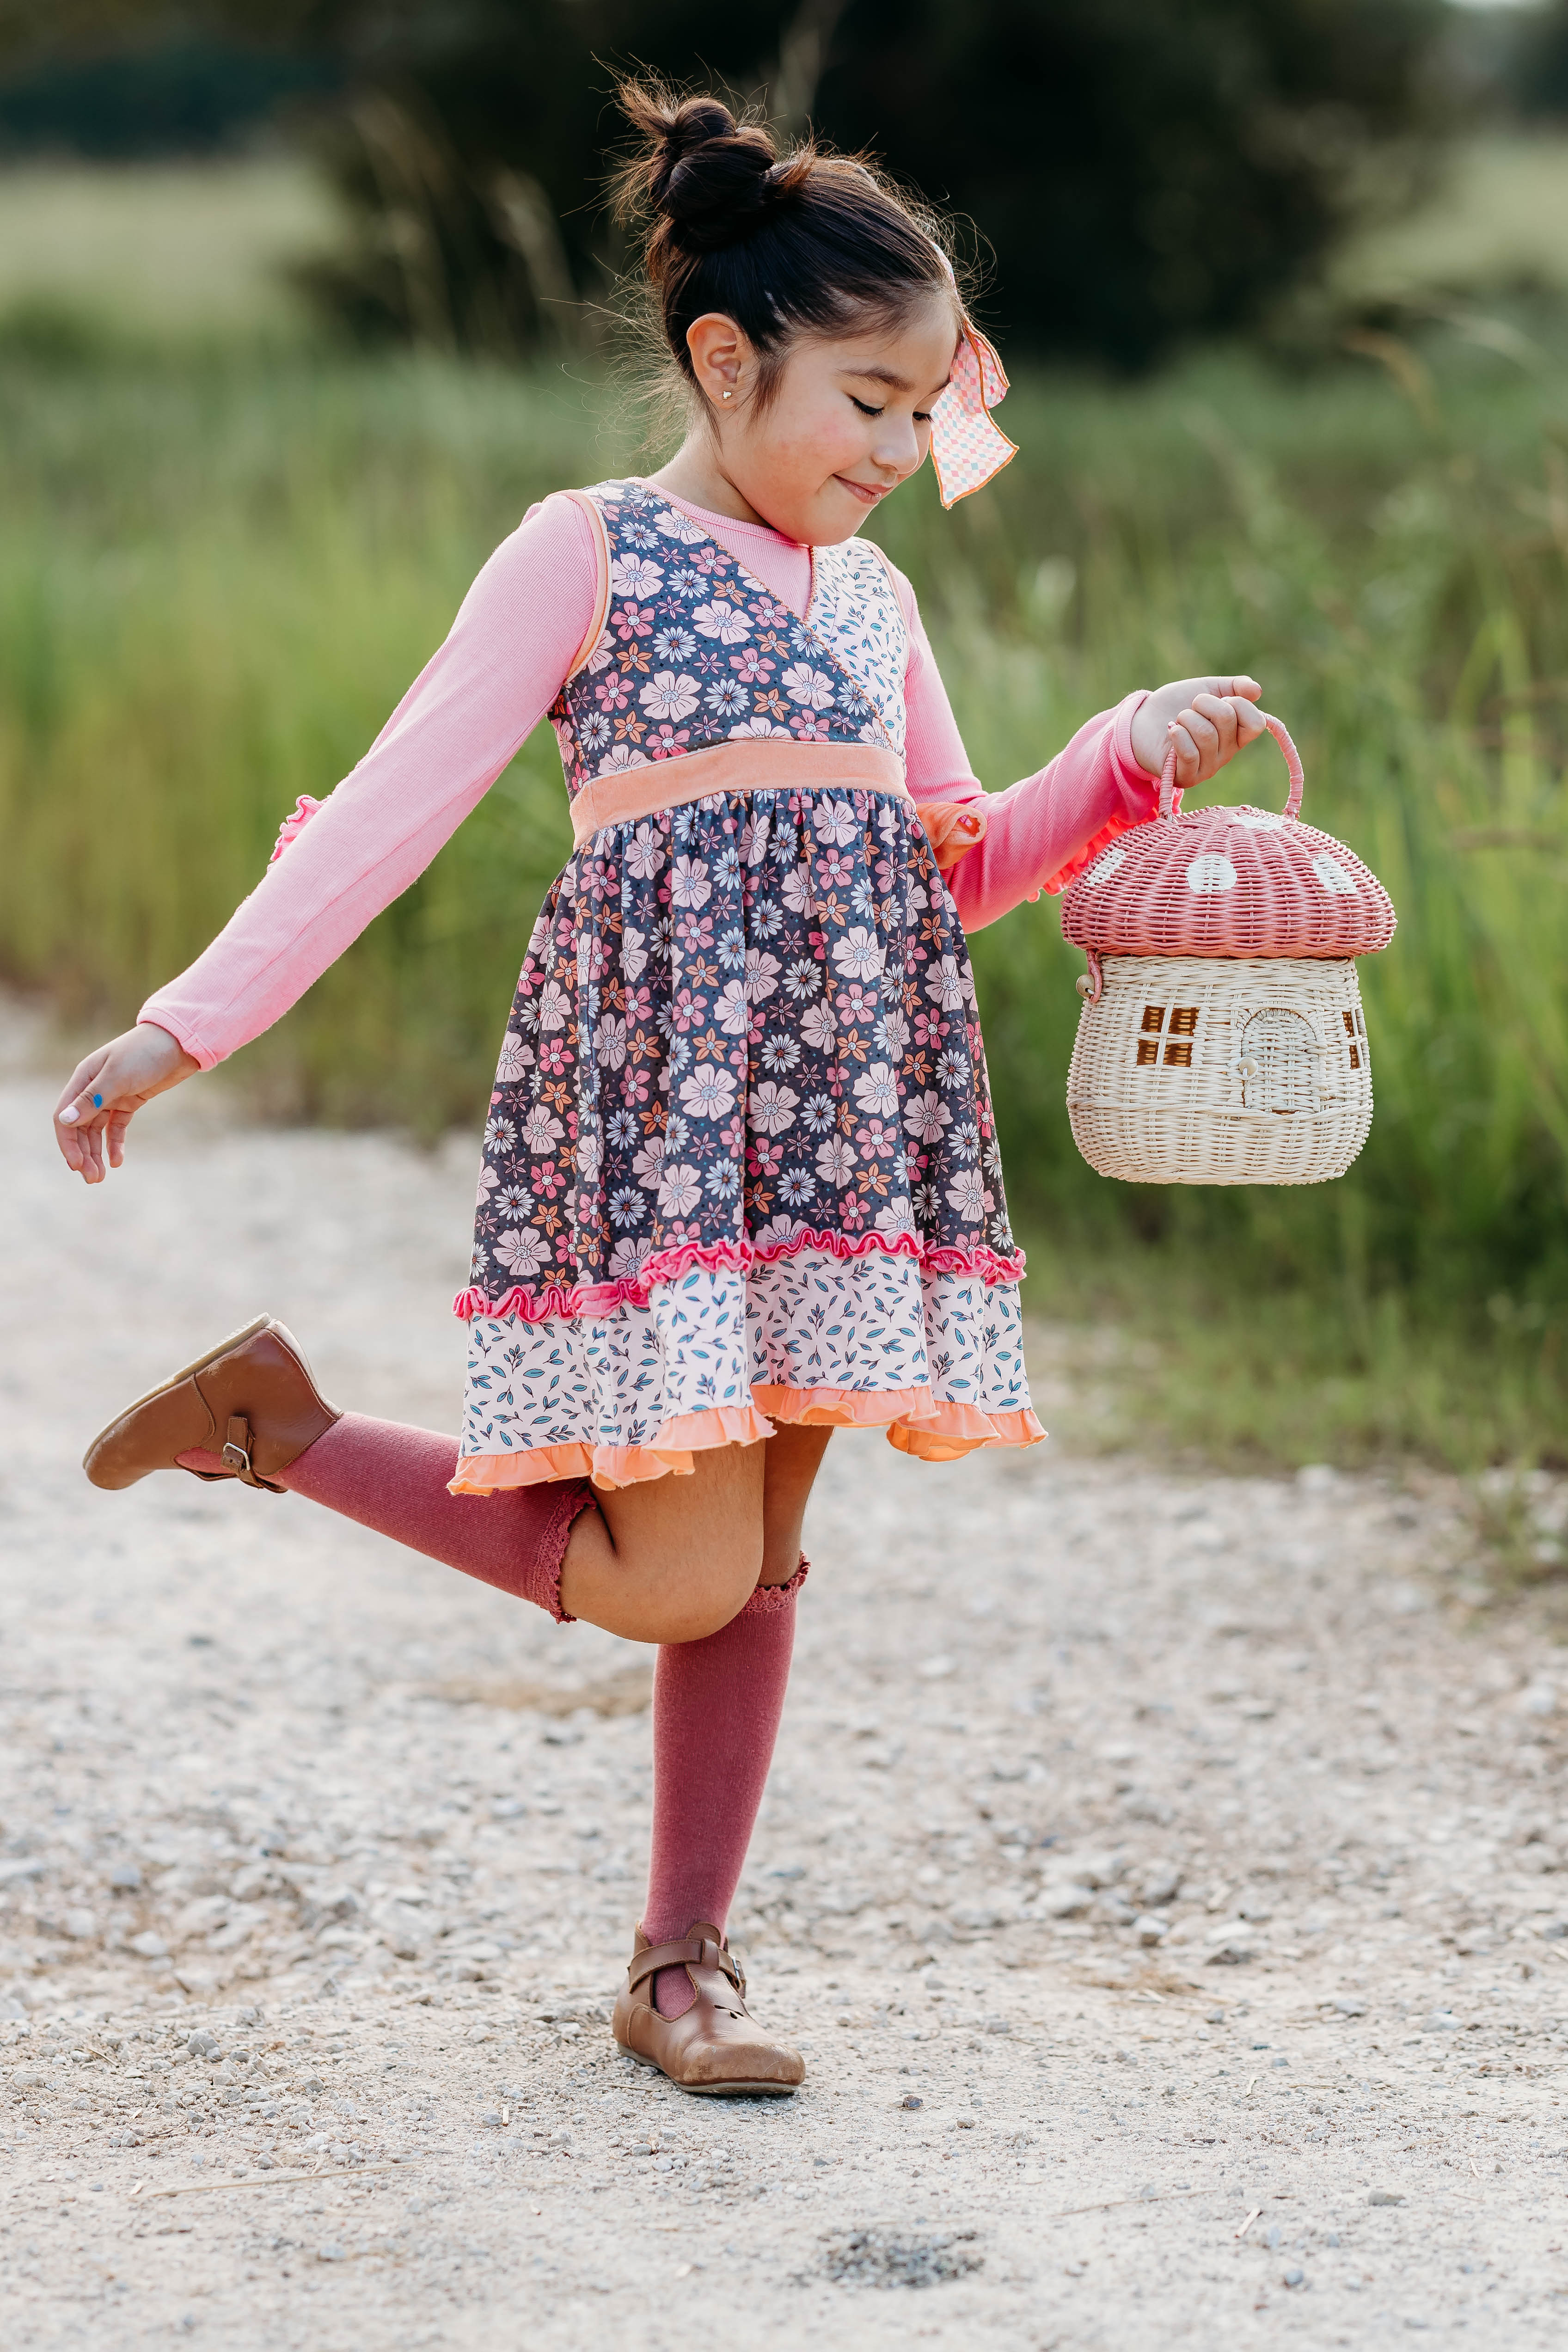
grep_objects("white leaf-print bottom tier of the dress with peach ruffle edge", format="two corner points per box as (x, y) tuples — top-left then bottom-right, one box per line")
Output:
(451, 1249), (1044, 1494)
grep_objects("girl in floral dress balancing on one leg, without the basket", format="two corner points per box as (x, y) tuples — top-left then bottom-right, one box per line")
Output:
(56, 85), (1260, 2093)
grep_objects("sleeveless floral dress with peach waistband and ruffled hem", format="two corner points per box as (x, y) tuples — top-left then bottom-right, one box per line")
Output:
(453, 482), (1041, 1494)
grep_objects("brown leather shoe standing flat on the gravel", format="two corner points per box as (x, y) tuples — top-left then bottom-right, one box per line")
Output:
(611, 1919), (806, 2098)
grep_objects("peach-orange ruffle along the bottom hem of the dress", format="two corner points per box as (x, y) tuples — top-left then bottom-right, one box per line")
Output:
(449, 1383), (1046, 1494)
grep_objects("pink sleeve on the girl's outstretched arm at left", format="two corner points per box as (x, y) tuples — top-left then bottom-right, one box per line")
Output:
(139, 496), (600, 1070)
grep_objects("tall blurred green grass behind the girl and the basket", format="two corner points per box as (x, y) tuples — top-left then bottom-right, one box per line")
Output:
(0, 320), (1568, 1465)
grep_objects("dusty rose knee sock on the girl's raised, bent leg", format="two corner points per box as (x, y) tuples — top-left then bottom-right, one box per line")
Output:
(181, 1414), (593, 1625)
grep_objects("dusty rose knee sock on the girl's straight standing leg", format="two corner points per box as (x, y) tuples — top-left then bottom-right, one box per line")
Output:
(642, 1559), (806, 2018)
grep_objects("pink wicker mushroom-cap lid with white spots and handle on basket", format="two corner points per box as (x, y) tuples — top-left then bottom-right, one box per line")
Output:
(1063, 717), (1394, 957)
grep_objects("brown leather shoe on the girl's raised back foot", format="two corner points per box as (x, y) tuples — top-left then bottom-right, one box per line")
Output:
(82, 1315), (343, 1494)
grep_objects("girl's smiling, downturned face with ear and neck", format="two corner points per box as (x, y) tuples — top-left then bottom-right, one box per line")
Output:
(654, 289), (957, 548)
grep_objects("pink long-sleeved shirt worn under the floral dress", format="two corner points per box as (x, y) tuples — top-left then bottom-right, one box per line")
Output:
(139, 496), (1157, 1070)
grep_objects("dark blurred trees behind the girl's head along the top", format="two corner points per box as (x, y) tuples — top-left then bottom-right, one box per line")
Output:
(0, 0), (1453, 367)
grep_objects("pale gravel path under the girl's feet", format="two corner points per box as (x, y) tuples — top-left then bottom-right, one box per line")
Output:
(0, 1016), (1568, 2352)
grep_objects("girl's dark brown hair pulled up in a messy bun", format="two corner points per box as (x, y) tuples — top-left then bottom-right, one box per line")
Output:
(616, 80), (957, 409)
